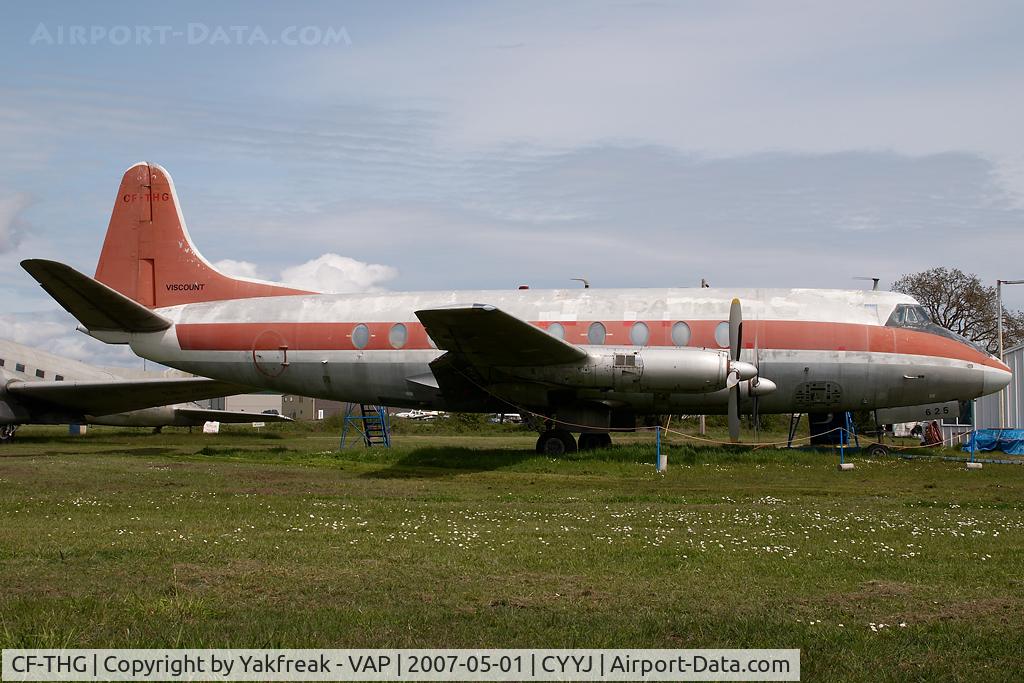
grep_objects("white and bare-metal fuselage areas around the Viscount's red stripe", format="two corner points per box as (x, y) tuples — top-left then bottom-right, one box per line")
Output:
(117, 289), (1006, 414)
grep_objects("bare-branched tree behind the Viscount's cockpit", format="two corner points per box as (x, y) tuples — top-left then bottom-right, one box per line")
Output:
(893, 267), (1024, 353)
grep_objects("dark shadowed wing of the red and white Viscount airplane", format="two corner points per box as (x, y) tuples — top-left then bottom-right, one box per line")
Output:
(416, 304), (587, 368)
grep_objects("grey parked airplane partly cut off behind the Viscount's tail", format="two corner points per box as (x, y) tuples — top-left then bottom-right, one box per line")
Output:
(0, 339), (288, 442)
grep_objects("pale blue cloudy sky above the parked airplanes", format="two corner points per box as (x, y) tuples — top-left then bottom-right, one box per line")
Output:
(0, 0), (1024, 365)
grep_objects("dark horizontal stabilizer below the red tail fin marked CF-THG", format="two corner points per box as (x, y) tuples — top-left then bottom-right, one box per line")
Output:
(22, 259), (171, 333)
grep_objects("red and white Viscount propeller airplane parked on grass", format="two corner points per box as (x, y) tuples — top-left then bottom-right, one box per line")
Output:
(23, 163), (1010, 453)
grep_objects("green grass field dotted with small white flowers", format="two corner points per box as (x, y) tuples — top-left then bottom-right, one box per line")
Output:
(0, 428), (1024, 681)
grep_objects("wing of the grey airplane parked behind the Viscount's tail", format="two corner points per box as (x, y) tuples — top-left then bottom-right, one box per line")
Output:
(7, 377), (251, 417)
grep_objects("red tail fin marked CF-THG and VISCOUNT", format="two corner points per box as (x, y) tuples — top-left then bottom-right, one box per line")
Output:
(96, 163), (310, 308)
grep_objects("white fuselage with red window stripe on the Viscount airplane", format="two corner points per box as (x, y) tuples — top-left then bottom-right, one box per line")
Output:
(130, 289), (1009, 414)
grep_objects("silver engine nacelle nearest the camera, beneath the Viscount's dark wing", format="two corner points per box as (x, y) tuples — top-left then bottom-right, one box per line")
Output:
(510, 347), (754, 393)
